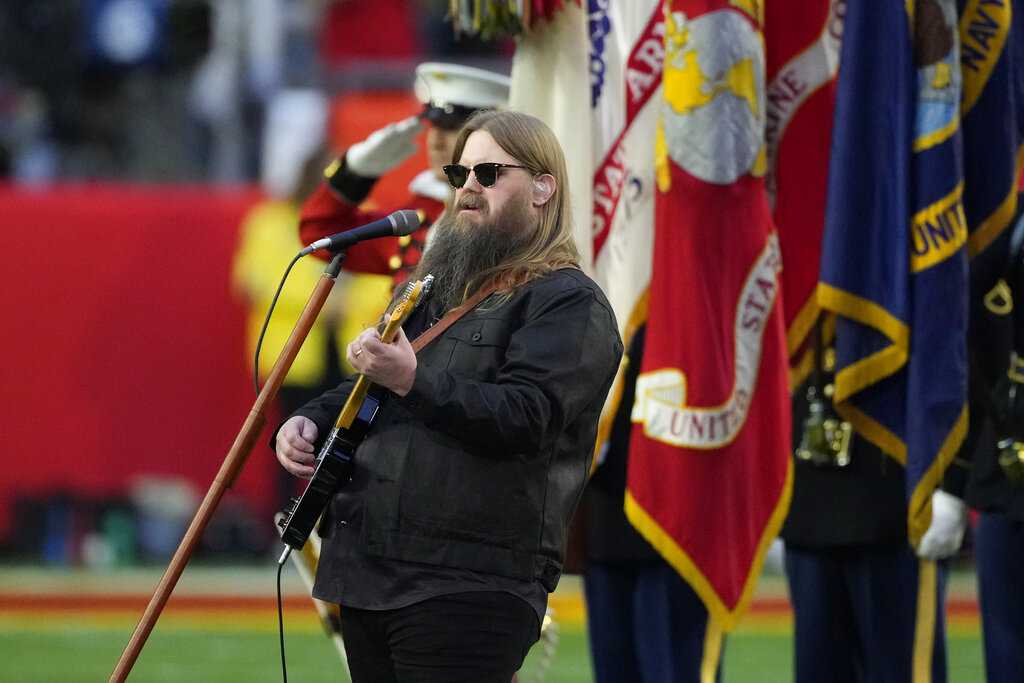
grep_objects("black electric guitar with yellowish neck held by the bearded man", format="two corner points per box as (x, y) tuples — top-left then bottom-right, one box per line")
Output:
(278, 275), (433, 550)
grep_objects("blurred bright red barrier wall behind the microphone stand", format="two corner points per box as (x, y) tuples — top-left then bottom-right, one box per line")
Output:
(0, 185), (281, 539)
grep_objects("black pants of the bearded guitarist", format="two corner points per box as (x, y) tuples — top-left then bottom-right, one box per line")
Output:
(341, 591), (540, 683)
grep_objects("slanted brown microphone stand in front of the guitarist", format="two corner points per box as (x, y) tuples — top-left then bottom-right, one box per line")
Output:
(110, 251), (345, 683)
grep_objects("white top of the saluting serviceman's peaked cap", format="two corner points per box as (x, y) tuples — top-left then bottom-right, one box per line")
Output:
(415, 61), (512, 109)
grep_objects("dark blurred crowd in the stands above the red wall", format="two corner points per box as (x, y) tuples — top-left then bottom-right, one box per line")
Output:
(0, 0), (512, 183)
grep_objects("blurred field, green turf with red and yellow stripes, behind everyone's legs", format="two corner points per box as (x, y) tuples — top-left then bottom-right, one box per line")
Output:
(0, 567), (984, 683)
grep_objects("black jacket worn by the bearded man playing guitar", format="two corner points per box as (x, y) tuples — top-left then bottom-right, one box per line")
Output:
(297, 268), (623, 591)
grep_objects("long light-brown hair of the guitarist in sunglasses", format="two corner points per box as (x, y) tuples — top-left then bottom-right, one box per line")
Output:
(452, 110), (580, 300)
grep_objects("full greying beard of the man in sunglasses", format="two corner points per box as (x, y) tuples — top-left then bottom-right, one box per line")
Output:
(413, 189), (534, 311)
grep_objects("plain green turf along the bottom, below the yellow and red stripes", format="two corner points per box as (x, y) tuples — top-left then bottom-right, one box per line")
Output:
(0, 629), (984, 683)
